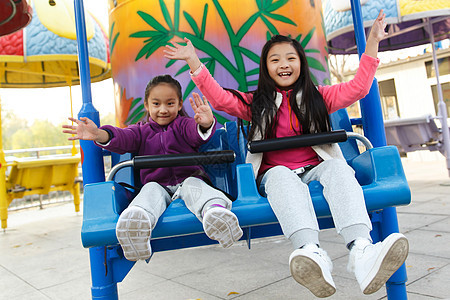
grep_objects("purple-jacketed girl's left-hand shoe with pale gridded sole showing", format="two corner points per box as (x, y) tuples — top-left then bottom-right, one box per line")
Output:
(116, 206), (152, 261)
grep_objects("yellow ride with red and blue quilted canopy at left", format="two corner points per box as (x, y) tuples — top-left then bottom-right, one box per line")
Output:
(0, 0), (111, 230)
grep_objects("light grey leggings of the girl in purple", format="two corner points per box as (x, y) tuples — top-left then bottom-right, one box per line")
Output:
(126, 177), (232, 229)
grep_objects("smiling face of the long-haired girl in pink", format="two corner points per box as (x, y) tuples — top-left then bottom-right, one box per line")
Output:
(266, 43), (301, 90)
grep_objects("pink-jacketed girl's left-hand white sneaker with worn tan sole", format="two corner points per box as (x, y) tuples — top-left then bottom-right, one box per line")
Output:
(289, 244), (336, 298)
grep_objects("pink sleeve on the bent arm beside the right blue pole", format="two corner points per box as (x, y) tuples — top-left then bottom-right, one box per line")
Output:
(318, 54), (380, 114)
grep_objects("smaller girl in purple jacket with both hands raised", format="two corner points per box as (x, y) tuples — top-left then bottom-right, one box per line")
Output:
(63, 75), (242, 261)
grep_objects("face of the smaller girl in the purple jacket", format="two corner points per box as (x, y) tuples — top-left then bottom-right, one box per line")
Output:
(144, 83), (183, 126)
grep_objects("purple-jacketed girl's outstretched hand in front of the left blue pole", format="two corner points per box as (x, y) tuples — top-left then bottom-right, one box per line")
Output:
(62, 117), (109, 143)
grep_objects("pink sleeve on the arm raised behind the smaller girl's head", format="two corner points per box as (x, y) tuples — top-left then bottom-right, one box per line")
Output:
(191, 67), (253, 121)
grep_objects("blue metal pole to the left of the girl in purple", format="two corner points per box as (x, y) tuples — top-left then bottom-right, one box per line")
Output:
(74, 0), (112, 300)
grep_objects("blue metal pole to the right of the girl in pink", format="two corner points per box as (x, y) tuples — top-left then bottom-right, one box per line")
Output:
(350, 0), (407, 300)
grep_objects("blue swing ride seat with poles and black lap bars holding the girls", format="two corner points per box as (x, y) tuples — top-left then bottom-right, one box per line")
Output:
(4, 0), (450, 299)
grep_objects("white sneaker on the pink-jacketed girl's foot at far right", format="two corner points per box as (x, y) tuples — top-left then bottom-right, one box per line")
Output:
(347, 233), (409, 295)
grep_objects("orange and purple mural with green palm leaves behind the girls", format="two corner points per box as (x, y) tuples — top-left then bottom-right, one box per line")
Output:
(109, 0), (330, 127)
